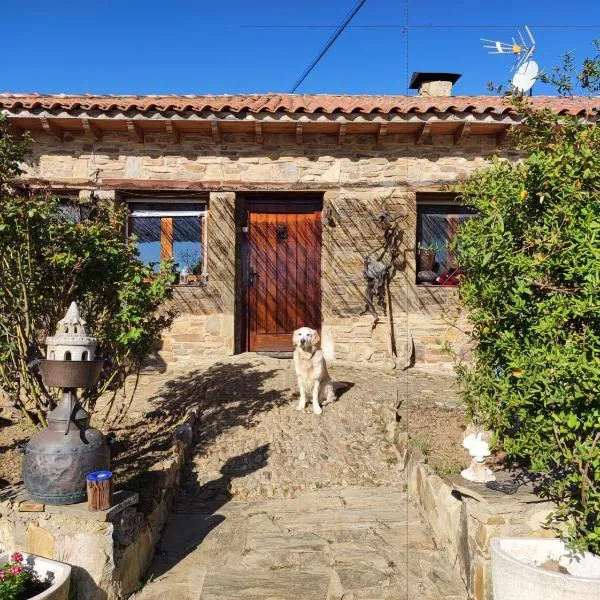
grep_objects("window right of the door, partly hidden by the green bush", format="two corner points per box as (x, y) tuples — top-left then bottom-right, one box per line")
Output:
(417, 200), (473, 285)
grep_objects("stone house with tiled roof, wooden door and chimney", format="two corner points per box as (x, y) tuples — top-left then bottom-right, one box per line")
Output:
(0, 73), (591, 363)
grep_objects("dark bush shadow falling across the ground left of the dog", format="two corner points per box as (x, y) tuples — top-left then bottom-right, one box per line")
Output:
(111, 362), (291, 500)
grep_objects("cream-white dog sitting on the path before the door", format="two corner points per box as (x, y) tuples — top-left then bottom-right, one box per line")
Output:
(292, 327), (335, 415)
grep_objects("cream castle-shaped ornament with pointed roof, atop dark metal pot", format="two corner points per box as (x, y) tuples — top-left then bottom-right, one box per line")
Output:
(46, 302), (98, 361)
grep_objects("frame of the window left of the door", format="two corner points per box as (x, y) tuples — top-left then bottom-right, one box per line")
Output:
(125, 197), (208, 282)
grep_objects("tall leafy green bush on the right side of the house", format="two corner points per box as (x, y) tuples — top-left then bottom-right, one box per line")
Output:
(457, 86), (600, 553)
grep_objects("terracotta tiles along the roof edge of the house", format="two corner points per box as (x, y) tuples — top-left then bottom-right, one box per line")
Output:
(0, 94), (600, 115)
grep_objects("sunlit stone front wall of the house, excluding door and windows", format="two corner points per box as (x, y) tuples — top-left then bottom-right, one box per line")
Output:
(25, 132), (504, 362)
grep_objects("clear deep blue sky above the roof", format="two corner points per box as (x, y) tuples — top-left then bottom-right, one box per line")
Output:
(0, 0), (600, 95)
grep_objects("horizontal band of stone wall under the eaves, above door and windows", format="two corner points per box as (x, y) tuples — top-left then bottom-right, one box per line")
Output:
(24, 132), (506, 191)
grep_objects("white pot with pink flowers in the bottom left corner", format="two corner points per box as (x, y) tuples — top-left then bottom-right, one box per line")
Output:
(0, 550), (71, 600)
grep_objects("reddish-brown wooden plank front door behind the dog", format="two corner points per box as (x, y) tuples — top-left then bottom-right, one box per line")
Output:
(245, 203), (321, 352)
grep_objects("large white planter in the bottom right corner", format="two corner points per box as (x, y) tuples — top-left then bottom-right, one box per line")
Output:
(492, 538), (600, 600)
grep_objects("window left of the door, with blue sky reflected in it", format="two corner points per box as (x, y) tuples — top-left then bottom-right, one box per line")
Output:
(128, 201), (206, 283)
